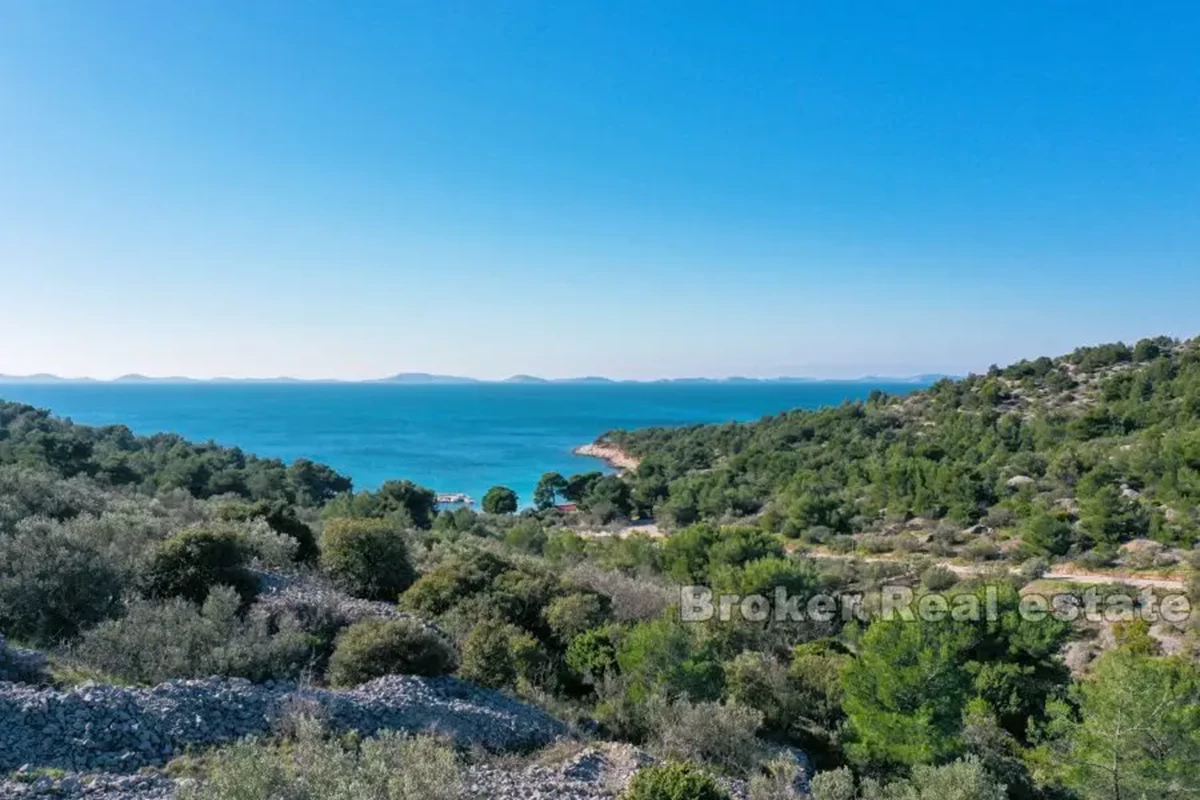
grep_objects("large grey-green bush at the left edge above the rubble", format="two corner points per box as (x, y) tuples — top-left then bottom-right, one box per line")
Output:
(0, 528), (121, 643)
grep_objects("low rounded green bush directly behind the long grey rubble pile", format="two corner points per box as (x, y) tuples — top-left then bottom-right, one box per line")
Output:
(328, 619), (457, 686)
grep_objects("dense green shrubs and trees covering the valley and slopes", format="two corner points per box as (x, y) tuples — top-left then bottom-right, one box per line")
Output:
(0, 339), (1200, 800)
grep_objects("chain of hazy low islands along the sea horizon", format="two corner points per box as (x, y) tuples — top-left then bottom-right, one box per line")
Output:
(0, 372), (956, 386)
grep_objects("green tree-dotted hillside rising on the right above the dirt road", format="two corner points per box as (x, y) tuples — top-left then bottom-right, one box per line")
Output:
(602, 338), (1200, 555)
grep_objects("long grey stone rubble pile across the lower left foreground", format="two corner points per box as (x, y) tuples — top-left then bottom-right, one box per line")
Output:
(0, 675), (563, 774)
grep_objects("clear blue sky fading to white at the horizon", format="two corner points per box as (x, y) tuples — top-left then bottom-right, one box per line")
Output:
(0, 0), (1200, 378)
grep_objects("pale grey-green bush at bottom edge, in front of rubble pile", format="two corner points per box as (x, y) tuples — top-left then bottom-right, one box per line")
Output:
(179, 720), (462, 800)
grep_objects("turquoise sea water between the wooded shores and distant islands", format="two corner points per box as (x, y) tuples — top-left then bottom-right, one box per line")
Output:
(0, 381), (914, 503)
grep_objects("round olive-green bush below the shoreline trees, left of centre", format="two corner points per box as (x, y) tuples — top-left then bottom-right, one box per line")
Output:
(320, 517), (416, 601)
